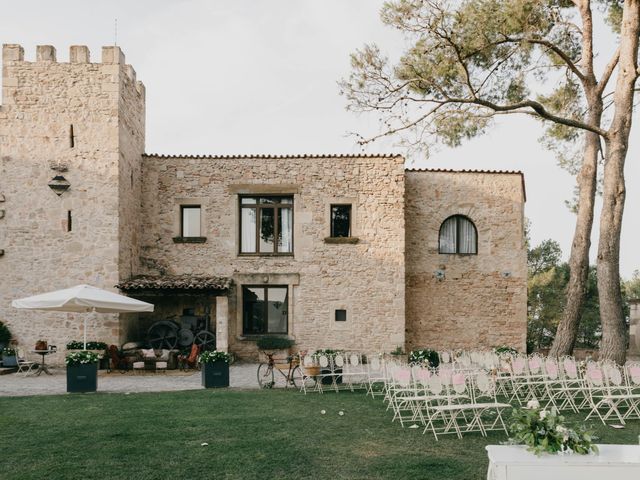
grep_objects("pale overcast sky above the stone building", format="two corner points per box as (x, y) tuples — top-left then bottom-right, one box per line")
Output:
(0, 0), (640, 277)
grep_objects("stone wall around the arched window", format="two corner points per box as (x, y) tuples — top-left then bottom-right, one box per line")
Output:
(405, 170), (527, 351)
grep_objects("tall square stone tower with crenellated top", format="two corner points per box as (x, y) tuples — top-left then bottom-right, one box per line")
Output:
(0, 45), (145, 356)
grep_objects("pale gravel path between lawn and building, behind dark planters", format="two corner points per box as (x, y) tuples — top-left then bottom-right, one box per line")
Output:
(0, 363), (284, 397)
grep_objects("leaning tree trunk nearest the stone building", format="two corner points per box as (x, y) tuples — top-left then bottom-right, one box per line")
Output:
(549, 122), (602, 357)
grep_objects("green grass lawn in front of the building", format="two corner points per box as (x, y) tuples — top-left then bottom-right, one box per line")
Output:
(0, 390), (640, 480)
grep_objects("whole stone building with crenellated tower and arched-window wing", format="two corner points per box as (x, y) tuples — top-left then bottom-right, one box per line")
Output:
(0, 45), (527, 361)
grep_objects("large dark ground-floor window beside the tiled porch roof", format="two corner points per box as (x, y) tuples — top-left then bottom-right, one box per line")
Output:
(242, 285), (289, 335)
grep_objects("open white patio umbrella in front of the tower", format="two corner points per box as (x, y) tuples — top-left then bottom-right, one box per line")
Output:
(11, 285), (153, 350)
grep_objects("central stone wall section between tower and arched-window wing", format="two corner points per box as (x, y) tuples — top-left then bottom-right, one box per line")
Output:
(141, 155), (405, 357)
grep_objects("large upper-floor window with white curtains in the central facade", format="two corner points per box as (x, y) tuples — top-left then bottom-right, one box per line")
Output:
(240, 196), (293, 255)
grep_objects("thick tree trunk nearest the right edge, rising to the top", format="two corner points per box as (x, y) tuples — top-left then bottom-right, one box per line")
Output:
(598, 0), (640, 364)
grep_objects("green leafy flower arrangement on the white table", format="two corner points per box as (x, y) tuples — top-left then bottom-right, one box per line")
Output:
(508, 400), (598, 455)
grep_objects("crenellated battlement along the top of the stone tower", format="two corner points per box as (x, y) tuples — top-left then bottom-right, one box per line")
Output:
(2, 44), (145, 97)
